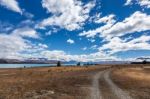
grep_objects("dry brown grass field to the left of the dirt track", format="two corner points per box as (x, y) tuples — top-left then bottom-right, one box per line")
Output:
(0, 66), (107, 99)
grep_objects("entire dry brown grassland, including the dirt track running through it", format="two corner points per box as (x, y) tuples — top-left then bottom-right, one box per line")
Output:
(0, 65), (150, 99)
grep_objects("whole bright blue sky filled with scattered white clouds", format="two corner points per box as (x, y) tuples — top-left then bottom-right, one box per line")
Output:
(0, 0), (150, 61)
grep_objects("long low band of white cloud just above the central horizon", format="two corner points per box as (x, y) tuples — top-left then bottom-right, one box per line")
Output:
(41, 50), (117, 62)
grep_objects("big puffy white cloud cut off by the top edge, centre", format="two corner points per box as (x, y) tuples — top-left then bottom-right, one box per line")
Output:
(38, 0), (95, 31)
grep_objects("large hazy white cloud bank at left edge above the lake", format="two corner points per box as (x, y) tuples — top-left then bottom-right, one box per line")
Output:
(0, 28), (43, 58)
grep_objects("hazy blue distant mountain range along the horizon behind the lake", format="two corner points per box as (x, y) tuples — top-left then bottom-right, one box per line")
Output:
(0, 58), (131, 65)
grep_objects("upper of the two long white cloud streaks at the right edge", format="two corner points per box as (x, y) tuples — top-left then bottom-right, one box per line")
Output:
(101, 11), (150, 38)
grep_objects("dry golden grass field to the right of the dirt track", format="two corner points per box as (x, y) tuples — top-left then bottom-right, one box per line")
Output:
(111, 67), (150, 99)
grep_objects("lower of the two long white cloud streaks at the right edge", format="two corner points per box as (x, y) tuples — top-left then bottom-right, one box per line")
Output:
(99, 35), (150, 54)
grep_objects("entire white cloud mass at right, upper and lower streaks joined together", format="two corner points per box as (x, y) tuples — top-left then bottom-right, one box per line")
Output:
(79, 11), (150, 55)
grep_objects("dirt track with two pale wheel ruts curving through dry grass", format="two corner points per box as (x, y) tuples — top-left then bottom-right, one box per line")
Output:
(91, 70), (132, 99)
